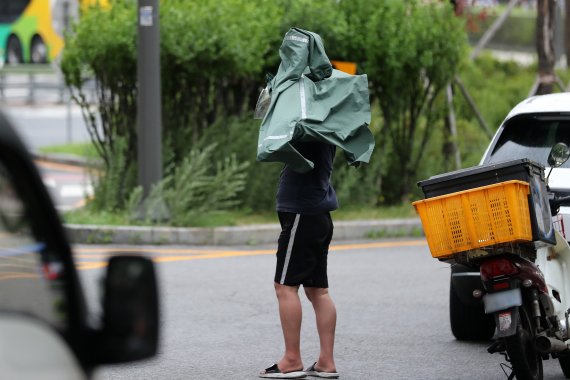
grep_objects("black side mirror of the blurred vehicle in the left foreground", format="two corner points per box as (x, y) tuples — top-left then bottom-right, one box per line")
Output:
(95, 256), (159, 363)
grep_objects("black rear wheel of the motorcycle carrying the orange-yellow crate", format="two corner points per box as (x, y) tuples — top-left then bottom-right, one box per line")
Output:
(505, 307), (543, 380)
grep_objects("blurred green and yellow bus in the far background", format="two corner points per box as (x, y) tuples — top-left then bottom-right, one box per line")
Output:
(0, 0), (108, 65)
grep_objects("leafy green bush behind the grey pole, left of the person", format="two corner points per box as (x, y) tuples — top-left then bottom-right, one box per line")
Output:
(62, 0), (272, 209)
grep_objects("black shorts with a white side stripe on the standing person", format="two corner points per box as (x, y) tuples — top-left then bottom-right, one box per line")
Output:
(275, 212), (333, 288)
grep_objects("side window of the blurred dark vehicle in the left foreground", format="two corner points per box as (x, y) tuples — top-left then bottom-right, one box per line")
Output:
(0, 162), (67, 329)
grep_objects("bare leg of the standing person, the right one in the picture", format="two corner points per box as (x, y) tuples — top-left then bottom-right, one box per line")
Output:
(305, 288), (336, 372)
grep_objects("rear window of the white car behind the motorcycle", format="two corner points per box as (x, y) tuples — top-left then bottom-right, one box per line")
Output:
(486, 117), (570, 168)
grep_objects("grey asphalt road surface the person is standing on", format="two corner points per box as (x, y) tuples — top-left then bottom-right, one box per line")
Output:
(71, 240), (564, 380)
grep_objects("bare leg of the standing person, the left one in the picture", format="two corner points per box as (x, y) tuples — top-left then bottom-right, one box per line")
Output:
(275, 283), (303, 372)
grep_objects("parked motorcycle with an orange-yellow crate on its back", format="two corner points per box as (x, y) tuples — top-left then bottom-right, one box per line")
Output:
(414, 143), (570, 380)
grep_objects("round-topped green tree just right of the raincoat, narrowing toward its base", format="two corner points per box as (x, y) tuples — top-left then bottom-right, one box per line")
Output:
(366, 0), (466, 201)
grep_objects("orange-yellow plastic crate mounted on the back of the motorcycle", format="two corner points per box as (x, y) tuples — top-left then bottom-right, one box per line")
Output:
(412, 181), (532, 258)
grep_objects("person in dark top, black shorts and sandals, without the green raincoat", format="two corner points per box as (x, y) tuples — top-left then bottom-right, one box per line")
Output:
(259, 142), (339, 379)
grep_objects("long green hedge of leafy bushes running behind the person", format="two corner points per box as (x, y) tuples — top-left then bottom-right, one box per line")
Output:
(62, 0), (533, 223)
